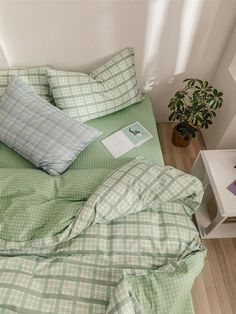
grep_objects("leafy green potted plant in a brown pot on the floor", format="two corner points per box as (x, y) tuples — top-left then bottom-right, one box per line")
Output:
(168, 78), (223, 147)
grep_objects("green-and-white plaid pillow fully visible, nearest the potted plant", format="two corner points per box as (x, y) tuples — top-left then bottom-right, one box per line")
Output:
(47, 48), (143, 122)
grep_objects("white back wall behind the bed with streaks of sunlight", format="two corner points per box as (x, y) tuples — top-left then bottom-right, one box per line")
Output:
(0, 0), (236, 121)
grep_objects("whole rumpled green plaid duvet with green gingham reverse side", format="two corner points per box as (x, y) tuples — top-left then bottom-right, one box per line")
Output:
(0, 160), (205, 314)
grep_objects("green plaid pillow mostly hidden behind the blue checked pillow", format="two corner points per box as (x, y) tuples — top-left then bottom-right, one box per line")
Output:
(0, 66), (52, 101)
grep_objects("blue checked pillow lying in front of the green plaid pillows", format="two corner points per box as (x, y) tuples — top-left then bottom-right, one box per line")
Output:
(0, 77), (101, 175)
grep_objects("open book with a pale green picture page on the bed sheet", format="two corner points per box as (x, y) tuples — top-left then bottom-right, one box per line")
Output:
(102, 121), (153, 158)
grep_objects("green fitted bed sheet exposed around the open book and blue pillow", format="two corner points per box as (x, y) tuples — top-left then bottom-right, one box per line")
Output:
(0, 96), (164, 170)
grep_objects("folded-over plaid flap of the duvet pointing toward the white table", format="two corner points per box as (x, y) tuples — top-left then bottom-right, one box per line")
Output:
(71, 160), (203, 237)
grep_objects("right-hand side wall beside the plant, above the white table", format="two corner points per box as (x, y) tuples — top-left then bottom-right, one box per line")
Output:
(203, 22), (236, 149)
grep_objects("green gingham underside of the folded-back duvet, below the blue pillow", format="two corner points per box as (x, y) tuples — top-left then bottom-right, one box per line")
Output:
(0, 168), (110, 244)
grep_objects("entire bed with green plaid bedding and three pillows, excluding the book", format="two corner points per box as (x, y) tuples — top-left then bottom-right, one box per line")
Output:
(0, 47), (206, 314)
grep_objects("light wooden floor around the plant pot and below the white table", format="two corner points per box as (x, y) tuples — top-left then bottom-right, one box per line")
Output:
(157, 123), (236, 314)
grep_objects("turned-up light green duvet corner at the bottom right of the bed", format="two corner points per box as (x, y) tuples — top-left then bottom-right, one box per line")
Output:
(107, 249), (206, 314)
